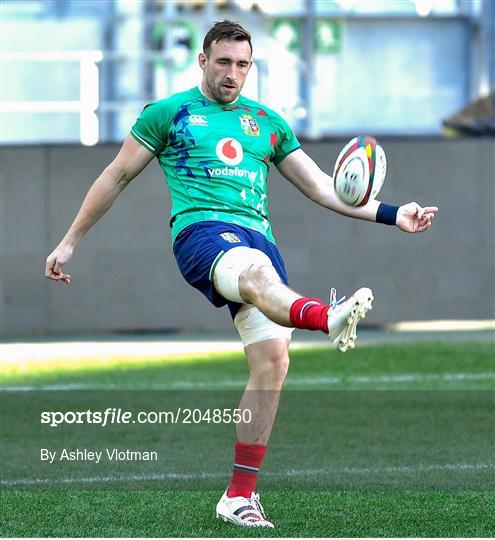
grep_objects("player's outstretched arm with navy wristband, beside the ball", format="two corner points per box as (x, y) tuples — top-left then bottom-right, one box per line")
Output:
(277, 149), (438, 233)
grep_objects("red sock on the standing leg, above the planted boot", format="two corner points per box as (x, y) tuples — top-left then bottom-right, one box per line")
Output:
(227, 441), (266, 498)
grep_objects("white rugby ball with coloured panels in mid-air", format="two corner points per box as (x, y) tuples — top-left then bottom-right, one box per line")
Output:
(333, 135), (387, 206)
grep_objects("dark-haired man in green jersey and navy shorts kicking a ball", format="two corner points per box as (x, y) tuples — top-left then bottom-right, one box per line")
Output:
(45, 21), (437, 527)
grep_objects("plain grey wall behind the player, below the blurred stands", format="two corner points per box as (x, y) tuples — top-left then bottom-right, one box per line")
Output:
(1, 139), (495, 338)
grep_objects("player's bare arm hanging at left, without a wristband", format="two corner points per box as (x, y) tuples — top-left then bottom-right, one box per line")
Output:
(45, 135), (154, 284)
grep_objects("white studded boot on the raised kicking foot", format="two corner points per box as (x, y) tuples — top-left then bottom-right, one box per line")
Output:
(327, 287), (373, 352)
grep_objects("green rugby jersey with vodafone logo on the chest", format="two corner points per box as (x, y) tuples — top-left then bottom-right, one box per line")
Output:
(131, 87), (300, 242)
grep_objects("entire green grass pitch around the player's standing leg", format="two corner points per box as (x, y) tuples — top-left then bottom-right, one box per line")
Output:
(0, 341), (495, 537)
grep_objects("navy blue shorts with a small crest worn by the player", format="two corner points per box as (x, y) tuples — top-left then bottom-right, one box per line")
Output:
(173, 221), (288, 318)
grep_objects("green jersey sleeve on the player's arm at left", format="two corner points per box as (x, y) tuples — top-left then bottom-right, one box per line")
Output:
(131, 100), (173, 156)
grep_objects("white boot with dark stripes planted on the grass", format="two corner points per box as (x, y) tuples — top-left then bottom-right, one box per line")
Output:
(217, 490), (274, 527)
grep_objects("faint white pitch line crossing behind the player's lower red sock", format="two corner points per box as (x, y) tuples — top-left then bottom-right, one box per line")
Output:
(0, 463), (495, 487)
